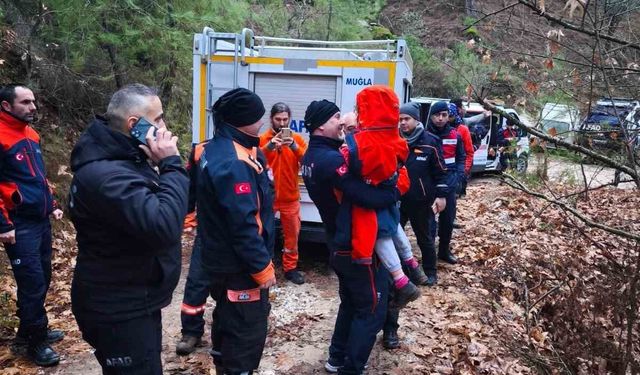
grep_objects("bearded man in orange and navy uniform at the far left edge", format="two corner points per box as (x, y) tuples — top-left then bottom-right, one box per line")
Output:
(0, 84), (64, 366)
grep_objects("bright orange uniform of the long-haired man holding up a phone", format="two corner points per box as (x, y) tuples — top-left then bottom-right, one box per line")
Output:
(260, 129), (307, 272)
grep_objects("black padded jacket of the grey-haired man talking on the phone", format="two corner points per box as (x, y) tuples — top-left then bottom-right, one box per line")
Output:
(69, 118), (189, 321)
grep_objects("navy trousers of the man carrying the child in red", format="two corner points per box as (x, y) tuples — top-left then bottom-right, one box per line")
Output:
(329, 251), (389, 374)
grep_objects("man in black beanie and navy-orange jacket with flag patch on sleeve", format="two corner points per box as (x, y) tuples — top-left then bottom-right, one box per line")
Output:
(196, 88), (276, 375)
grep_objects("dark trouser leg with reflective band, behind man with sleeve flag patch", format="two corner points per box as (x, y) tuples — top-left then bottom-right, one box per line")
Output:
(180, 235), (211, 337)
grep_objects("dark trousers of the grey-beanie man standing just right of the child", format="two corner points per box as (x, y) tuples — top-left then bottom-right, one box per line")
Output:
(400, 201), (438, 276)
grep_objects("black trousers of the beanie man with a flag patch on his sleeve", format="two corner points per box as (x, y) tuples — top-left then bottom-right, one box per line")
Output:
(211, 273), (271, 375)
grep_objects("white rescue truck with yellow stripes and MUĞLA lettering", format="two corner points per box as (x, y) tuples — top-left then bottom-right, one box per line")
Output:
(192, 27), (413, 242)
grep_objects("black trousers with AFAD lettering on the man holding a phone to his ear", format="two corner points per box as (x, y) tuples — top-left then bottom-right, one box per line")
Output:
(76, 310), (162, 375)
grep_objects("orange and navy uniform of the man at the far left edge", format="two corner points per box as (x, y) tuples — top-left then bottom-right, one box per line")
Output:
(0, 112), (54, 342)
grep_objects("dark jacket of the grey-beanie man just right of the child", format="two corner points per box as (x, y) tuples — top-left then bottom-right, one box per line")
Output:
(402, 130), (449, 204)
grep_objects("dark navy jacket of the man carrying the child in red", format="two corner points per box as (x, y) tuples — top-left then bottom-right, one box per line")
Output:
(302, 135), (400, 250)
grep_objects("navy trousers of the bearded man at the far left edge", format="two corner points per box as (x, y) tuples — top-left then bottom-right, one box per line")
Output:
(4, 218), (51, 342)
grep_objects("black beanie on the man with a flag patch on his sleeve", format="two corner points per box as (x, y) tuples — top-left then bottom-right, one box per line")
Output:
(212, 88), (265, 128)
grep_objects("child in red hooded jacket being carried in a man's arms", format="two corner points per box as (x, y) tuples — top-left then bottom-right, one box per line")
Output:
(336, 85), (426, 306)
